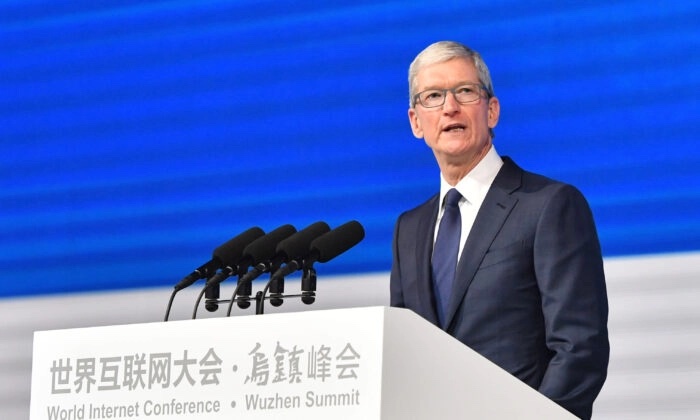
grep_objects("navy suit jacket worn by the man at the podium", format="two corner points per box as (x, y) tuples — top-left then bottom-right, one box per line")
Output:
(391, 157), (610, 419)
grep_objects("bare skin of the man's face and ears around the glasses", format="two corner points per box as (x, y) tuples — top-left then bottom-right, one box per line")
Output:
(408, 58), (500, 165)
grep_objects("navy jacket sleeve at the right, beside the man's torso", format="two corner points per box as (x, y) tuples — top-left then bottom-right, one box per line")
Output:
(534, 185), (610, 419)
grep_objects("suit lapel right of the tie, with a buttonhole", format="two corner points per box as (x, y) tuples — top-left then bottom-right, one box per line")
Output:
(445, 157), (522, 329)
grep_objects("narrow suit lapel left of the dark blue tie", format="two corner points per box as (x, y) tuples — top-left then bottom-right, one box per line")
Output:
(416, 194), (440, 325)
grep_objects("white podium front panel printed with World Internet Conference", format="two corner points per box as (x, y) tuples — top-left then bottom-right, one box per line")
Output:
(31, 310), (382, 420)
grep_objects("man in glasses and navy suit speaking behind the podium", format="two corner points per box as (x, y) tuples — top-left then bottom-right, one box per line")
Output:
(391, 41), (609, 419)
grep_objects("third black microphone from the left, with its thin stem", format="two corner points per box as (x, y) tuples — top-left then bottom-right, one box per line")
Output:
(257, 222), (331, 313)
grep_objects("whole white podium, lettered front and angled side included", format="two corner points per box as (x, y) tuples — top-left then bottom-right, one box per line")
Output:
(30, 307), (575, 420)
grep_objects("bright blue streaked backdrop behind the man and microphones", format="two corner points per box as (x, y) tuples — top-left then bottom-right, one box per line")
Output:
(0, 0), (700, 297)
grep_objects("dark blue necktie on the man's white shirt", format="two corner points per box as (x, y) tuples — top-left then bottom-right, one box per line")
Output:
(431, 188), (462, 326)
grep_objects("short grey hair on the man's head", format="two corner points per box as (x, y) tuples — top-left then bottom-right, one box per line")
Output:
(408, 41), (496, 108)
